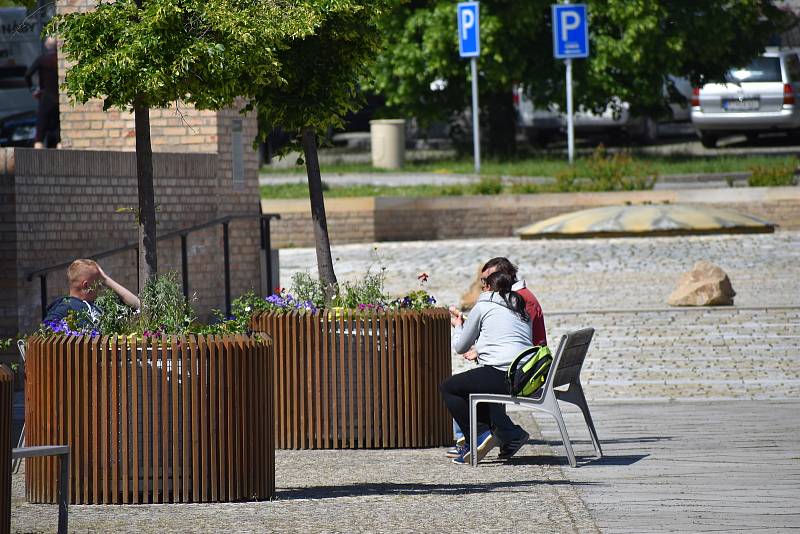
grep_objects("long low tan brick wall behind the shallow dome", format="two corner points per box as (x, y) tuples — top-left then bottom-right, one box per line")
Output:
(262, 187), (800, 248)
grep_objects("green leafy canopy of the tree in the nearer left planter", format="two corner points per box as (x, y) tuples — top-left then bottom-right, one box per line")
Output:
(51, 0), (317, 109)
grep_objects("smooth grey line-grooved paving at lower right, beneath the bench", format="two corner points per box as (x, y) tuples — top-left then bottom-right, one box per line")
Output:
(522, 404), (800, 534)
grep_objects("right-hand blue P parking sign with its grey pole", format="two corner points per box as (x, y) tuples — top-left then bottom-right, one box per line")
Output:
(551, 4), (589, 163)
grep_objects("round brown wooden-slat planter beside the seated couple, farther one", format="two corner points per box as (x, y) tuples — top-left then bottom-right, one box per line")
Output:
(253, 309), (452, 449)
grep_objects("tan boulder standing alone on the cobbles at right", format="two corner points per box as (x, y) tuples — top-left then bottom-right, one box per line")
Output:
(667, 260), (736, 306)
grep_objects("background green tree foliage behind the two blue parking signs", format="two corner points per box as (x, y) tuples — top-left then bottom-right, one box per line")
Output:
(374, 0), (790, 153)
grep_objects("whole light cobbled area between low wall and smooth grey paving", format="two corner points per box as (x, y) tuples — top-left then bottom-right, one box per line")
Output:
(281, 232), (800, 400)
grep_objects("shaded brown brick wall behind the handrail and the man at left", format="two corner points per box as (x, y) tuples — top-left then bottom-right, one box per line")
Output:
(6, 149), (260, 335)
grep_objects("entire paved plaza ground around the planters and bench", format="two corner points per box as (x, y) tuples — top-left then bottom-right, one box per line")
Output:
(7, 232), (800, 533)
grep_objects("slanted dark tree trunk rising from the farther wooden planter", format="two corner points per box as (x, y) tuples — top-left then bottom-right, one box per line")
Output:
(302, 127), (337, 305)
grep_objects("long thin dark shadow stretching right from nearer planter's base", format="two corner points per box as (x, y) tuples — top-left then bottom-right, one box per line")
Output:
(276, 482), (585, 499)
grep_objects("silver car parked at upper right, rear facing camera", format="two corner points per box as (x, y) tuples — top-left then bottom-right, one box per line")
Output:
(692, 49), (800, 148)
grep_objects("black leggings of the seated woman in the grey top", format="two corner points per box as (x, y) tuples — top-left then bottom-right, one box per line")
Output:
(439, 366), (508, 442)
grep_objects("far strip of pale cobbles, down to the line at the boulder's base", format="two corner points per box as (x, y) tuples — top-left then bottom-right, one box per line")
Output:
(280, 232), (800, 313)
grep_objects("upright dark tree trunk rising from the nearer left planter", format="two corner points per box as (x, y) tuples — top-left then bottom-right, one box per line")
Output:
(133, 102), (158, 291)
